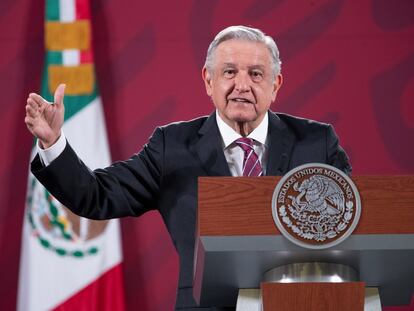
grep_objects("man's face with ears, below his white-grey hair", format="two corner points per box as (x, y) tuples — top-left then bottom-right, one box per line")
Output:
(202, 39), (282, 131)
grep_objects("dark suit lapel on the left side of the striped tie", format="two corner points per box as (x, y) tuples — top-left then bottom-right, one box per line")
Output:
(191, 112), (231, 176)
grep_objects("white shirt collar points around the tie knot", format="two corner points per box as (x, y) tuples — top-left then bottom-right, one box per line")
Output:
(216, 110), (269, 149)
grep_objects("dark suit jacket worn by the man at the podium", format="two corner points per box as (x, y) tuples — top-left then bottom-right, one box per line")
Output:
(31, 112), (351, 308)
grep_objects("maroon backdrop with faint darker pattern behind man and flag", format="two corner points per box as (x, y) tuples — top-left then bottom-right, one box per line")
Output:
(0, 0), (414, 310)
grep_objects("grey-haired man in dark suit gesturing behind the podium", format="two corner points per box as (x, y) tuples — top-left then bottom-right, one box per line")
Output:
(25, 26), (351, 310)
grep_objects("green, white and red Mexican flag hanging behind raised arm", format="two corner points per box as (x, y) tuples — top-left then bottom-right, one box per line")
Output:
(17, 0), (125, 311)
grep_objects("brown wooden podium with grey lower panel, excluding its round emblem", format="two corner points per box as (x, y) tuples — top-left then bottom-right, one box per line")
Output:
(193, 175), (414, 310)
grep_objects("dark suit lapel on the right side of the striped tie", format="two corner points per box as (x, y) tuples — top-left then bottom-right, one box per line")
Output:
(266, 111), (295, 176)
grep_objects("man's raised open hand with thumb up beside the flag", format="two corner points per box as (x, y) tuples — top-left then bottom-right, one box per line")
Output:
(24, 84), (66, 148)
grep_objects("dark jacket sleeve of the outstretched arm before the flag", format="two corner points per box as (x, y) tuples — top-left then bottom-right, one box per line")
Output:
(31, 128), (164, 219)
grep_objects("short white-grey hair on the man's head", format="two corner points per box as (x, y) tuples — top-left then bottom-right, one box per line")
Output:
(204, 26), (282, 76)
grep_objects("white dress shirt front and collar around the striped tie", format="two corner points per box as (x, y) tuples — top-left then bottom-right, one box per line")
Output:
(216, 111), (269, 176)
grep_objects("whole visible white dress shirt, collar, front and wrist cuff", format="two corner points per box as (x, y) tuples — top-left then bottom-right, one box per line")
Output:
(37, 111), (269, 176)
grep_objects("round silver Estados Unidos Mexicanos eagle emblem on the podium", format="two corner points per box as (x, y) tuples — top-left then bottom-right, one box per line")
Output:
(272, 163), (361, 249)
